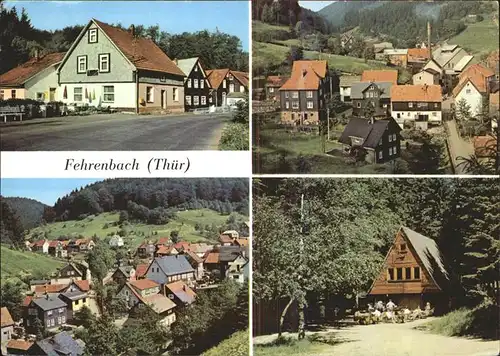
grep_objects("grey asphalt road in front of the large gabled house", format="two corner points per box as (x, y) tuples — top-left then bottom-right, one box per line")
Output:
(0, 114), (231, 151)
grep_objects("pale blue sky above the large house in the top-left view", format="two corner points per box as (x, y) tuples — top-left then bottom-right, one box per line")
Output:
(5, 1), (249, 51)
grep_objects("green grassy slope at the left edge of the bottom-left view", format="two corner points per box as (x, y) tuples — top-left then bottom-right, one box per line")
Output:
(0, 246), (63, 280)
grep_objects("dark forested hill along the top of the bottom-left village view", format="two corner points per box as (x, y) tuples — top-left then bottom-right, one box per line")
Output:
(44, 178), (249, 224)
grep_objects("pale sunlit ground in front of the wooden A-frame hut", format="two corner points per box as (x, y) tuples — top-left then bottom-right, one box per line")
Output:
(254, 318), (499, 356)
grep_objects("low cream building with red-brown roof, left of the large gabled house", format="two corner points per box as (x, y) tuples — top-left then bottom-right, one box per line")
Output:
(0, 51), (64, 102)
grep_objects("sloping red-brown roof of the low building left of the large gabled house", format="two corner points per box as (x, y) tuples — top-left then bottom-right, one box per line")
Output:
(0, 53), (64, 86)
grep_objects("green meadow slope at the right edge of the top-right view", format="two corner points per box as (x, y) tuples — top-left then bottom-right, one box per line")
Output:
(448, 16), (498, 55)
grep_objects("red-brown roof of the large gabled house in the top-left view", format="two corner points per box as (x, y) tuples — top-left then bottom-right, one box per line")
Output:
(92, 19), (186, 77)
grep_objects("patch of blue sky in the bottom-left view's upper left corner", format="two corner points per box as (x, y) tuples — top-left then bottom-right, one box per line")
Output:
(0, 178), (103, 205)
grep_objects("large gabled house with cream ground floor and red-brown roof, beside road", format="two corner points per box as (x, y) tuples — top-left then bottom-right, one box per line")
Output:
(58, 19), (185, 112)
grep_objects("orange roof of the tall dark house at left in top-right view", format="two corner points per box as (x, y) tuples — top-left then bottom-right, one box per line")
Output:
(280, 61), (328, 90)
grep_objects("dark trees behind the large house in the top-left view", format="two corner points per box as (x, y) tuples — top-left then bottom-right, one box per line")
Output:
(0, 0), (248, 73)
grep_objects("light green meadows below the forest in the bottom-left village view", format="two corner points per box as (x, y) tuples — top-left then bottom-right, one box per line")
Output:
(30, 209), (247, 247)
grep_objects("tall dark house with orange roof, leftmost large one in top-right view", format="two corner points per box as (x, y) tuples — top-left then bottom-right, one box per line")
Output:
(280, 60), (338, 126)
